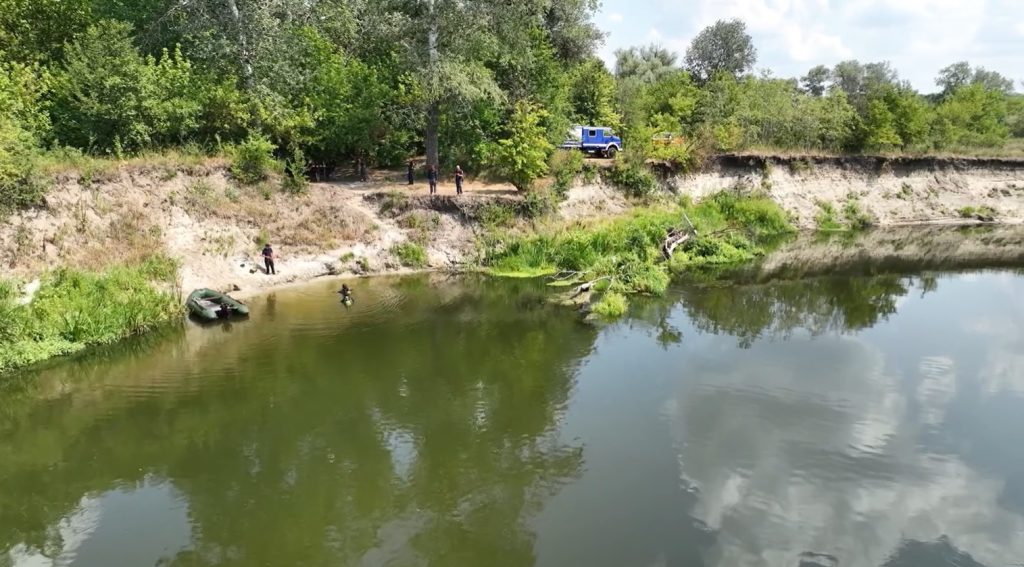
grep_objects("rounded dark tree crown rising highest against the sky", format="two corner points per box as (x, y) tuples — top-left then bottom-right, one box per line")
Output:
(686, 19), (758, 82)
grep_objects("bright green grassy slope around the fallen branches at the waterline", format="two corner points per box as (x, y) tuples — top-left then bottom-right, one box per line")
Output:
(482, 192), (795, 316)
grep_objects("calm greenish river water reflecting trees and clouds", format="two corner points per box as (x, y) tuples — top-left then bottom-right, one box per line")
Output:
(0, 230), (1024, 567)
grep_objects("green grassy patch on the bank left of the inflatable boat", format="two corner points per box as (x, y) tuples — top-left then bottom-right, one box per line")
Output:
(0, 256), (181, 373)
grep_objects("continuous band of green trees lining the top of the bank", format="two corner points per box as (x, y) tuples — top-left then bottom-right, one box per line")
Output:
(0, 6), (1024, 208)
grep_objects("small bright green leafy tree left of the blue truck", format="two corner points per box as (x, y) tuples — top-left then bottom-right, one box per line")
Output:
(490, 101), (554, 191)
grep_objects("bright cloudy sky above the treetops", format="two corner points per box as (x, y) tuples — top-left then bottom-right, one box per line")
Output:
(597, 0), (1024, 92)
